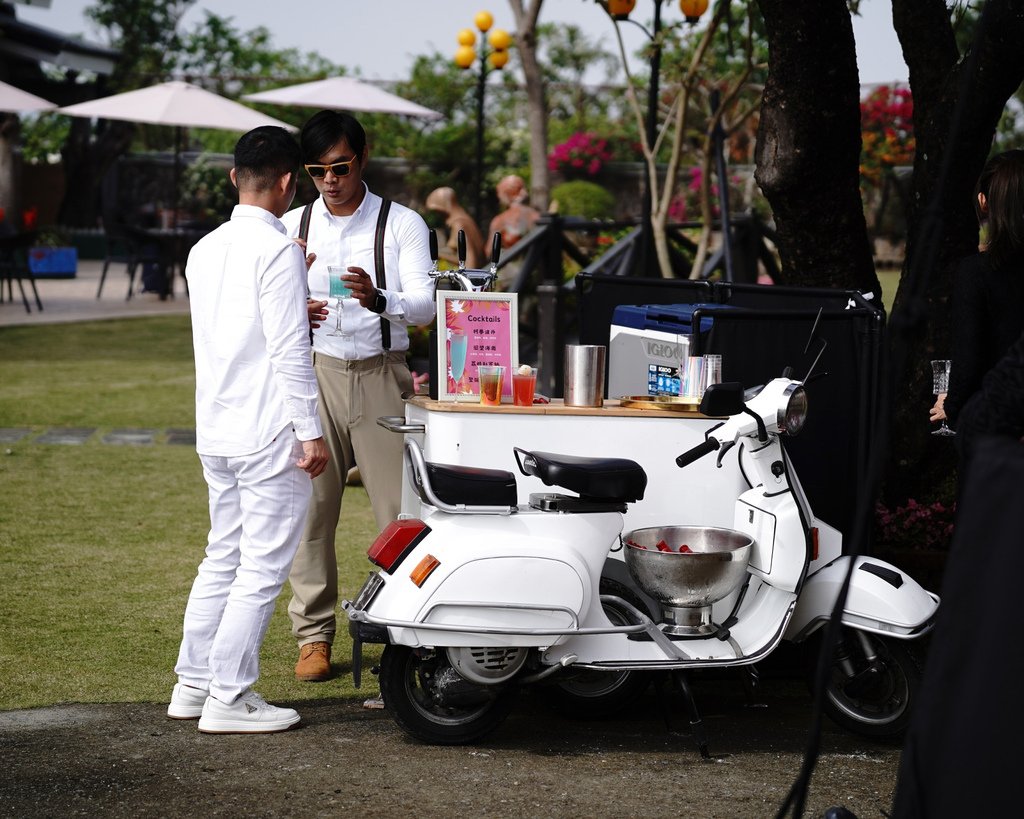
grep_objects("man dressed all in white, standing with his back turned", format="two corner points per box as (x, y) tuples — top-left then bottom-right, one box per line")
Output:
(167, 127), (328, 733)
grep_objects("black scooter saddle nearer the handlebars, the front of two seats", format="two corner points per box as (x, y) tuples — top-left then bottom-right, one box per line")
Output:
(515, 447), (647, 504)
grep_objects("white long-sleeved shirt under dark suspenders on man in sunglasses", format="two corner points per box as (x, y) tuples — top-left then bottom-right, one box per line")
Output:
(282, 190), (436, 360)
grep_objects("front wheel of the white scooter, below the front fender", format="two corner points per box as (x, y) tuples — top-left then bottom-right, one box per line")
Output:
(812, 629), (922, 741)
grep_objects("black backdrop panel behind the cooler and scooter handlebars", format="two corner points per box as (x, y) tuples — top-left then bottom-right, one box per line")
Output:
(577, 273), (884, 549)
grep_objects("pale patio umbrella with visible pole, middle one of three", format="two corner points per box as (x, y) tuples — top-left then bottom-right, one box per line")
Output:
(57, 80), (297, 228)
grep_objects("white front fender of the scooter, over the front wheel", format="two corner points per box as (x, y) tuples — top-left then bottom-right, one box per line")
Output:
(784, 555), (939, 642)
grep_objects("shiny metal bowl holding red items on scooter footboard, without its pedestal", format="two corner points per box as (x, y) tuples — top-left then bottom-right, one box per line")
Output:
(623, 526), (754, 608)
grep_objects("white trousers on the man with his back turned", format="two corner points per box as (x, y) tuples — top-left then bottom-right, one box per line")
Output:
(174, 427), (312, 704)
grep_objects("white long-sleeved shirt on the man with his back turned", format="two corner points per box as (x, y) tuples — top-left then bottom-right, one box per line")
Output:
(185, 205), (321, 457)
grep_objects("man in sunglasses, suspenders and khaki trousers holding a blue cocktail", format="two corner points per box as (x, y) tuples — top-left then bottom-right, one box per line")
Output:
(283, 111), (434, 682)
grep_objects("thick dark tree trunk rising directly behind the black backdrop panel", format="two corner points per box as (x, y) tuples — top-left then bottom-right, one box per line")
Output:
(756, 0), (881, 297)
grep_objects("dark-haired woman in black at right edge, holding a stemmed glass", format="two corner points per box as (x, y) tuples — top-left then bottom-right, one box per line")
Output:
(930, 149), (1024, 434)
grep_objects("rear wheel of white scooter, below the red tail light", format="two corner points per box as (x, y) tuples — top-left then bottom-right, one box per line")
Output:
(380, 645), (517, 745)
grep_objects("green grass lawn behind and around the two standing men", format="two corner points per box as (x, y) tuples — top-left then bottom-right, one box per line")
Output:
(0, 316), (376, 709)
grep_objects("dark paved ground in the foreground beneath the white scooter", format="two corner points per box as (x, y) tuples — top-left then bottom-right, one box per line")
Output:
(0, 679), (899, 819)
